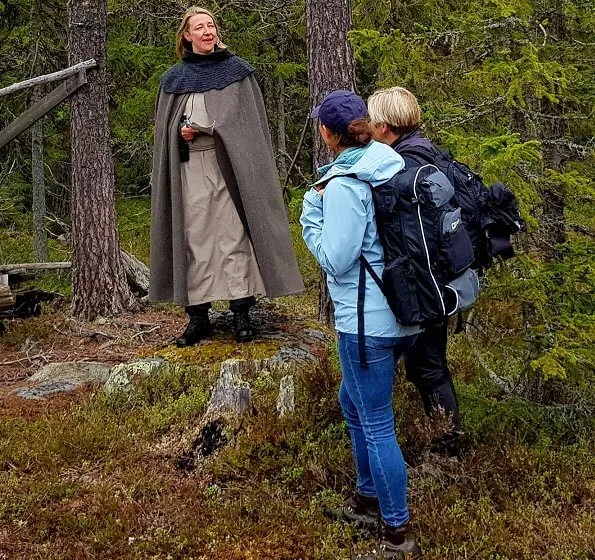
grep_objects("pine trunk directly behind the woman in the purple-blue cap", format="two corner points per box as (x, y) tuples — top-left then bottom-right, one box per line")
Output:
(306, 0), (355, 325)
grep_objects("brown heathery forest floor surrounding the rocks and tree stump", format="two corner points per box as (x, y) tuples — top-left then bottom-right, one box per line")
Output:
(0, 306), (595, 560)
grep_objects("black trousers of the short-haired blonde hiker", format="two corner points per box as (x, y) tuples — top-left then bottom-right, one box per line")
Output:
(403, 321), (461, 430)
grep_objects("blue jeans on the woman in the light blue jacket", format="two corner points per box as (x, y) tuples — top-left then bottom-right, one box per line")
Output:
(339, 332), (417, 527)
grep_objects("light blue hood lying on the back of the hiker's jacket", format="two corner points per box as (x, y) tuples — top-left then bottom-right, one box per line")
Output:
(314, 141), (405, 187)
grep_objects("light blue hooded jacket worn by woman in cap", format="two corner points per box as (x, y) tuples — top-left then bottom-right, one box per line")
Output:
(300, 142), (421, 337)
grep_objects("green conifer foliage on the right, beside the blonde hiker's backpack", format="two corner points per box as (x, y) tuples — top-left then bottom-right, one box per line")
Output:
(352, 0), (595, 399)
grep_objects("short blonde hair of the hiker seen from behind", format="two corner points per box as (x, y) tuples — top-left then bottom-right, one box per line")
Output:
(368, 87), (421, 134)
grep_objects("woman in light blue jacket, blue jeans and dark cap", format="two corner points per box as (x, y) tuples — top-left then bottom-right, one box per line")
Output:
(300, 90), (421, 558)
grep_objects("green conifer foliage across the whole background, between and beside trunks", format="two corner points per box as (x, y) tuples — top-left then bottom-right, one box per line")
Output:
(0, 0), (595, 399)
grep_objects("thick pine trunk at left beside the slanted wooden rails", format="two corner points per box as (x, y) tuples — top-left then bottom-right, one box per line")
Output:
(68, 0), (135, 319)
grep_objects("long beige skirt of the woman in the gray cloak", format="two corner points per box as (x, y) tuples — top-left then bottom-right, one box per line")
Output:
(182, 134), (265, 305)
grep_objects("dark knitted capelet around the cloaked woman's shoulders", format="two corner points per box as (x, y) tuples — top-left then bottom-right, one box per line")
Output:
(159, 48), (254, 95)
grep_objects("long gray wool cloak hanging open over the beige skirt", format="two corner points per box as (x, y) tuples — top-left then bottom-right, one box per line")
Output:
(149, 74), (304, 305)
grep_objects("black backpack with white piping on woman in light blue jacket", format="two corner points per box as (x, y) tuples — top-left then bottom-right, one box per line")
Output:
(360, 164), (479, 325)
